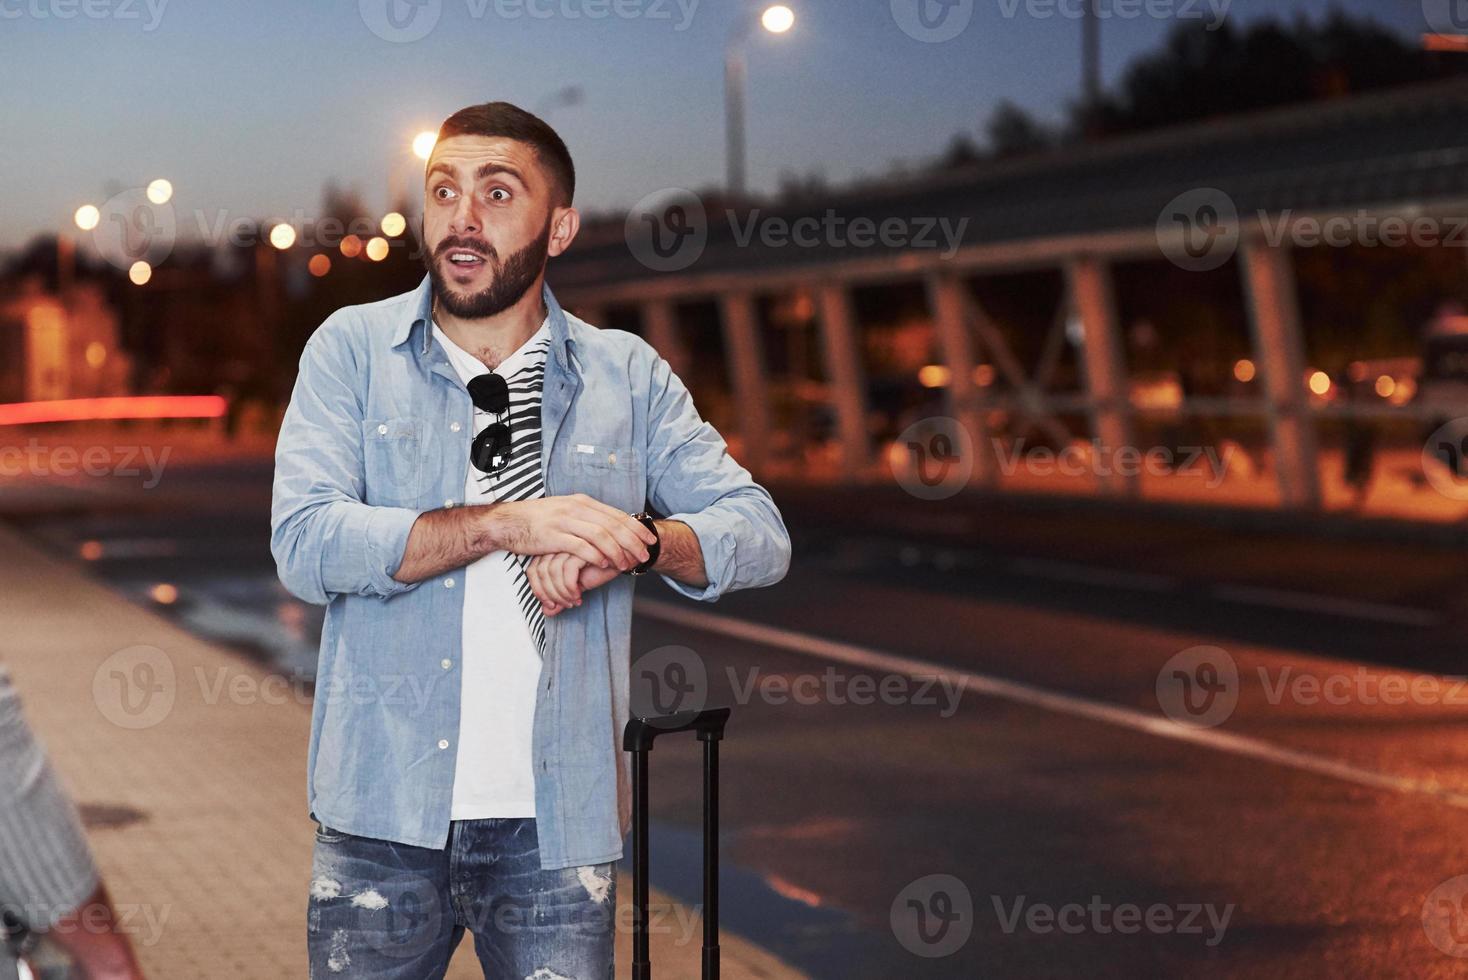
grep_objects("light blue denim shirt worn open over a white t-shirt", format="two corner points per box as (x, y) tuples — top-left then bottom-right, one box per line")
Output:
(270, 277), (790, 870)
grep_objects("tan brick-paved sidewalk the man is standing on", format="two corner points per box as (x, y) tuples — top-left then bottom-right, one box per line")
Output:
(0, 525), (800, 980)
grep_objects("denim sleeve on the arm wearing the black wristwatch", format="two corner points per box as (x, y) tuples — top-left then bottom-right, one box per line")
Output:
(647, 348), (790, 601)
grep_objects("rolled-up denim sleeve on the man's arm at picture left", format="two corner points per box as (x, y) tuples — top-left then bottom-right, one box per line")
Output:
(270, 320), (418, 606)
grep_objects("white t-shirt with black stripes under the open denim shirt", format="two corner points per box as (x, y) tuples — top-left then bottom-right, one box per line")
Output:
(433, 321), (551, 820)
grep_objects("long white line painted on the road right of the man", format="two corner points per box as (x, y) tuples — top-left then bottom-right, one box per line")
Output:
(634, 599), (1468, 810)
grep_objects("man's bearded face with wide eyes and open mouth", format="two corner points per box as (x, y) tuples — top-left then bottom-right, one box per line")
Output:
(423, 136), (565, 318)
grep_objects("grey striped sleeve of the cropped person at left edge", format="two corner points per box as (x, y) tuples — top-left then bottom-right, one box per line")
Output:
(0, 668), (98, 930)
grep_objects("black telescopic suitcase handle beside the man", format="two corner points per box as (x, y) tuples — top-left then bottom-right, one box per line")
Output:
(622, 707), (730, 980)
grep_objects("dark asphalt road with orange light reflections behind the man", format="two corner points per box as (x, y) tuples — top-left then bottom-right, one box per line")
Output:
(10, 464), (1468, 977)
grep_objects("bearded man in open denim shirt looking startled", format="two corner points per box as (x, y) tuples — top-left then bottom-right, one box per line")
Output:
(272, 103), (790, 980)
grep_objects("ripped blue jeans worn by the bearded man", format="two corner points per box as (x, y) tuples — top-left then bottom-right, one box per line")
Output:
(307, 817), (617, 980)
